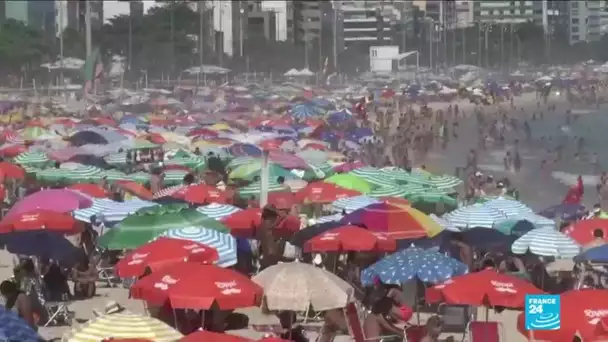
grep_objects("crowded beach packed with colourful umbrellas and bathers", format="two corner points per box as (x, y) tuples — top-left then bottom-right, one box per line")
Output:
(0, 71), (608, 342)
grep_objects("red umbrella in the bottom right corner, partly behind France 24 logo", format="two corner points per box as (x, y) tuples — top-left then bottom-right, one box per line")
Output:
(517, 289), (608, 341)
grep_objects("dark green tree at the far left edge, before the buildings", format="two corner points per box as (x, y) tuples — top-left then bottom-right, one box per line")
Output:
(0, 19), (51, 75)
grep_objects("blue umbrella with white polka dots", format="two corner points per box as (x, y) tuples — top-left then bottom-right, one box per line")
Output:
(361, 247), (468, 286)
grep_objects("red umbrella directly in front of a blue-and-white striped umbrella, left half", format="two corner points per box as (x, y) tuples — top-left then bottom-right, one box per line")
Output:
(115, 237), (219, 278)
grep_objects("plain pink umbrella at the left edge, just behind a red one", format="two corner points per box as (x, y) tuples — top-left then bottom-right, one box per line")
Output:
(5, 189), (93, 219)
